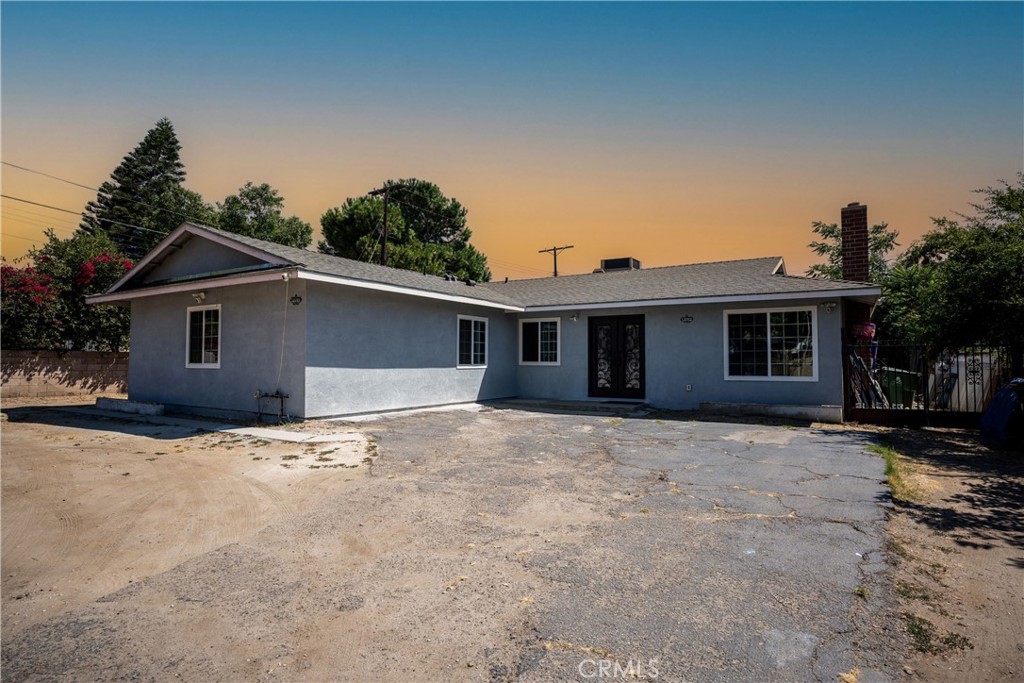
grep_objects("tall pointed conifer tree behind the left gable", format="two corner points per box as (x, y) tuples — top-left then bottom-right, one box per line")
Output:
(80, 119), (212, 258)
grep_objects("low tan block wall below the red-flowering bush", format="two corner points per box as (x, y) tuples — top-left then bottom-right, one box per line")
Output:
(0, 350), (128, 398)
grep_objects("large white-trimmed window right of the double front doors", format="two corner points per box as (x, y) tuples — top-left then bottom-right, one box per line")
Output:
(724, 307), (818, 382)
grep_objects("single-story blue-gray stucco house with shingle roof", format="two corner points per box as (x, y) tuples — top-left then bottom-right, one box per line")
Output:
(89, 208), (880, 419)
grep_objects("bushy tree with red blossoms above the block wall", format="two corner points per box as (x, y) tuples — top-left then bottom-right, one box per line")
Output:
(3, 229), (132, 351)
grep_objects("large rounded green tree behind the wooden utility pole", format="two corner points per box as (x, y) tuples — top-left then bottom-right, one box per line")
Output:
(317, 178), (490, 282)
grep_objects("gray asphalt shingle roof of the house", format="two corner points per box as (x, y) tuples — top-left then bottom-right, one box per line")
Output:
(116, 223), (877, 307)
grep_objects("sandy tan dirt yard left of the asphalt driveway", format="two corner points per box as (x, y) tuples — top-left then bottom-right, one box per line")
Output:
(0, 397), (368, 634)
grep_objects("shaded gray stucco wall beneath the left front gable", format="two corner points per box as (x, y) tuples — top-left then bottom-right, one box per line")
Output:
(128, 280), (306, 417)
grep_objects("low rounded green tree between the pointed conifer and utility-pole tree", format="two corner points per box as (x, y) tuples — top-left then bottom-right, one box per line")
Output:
(216, 182), (313, 249)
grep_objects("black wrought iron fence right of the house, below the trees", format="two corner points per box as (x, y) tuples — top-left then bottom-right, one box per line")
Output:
(846, 342), (1011, 414)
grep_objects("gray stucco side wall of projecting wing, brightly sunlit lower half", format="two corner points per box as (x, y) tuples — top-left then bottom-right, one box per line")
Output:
(303, 282), (517, 417)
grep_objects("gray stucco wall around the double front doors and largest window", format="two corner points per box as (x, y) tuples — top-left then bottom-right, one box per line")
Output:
(515, 300), (843, 410)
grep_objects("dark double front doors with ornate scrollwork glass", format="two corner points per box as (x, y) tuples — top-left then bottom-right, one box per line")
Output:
(589, 315), (644, 398)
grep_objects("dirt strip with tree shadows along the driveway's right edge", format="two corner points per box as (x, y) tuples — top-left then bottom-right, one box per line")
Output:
(883, 430), (1024, 683)
